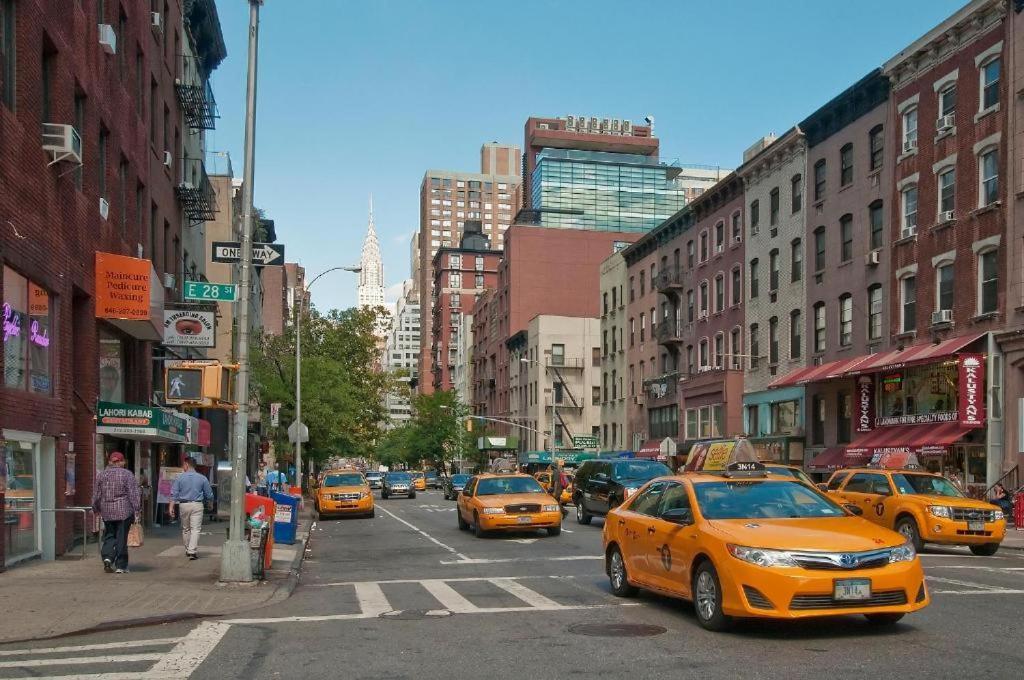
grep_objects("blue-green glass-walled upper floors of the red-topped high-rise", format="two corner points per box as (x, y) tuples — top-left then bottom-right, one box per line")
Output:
(530, 148), (686, 231)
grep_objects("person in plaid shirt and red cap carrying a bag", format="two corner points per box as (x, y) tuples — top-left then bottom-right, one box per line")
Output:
(92, 451), (142, 573)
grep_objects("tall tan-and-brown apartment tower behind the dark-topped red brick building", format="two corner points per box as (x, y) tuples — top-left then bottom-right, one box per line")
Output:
(412, 143), (521, 393)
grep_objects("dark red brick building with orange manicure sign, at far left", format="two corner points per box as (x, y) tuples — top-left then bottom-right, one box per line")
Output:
(0, 0), (224, 568)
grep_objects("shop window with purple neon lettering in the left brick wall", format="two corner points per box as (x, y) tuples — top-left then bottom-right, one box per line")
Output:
(3, 267), (53, 394)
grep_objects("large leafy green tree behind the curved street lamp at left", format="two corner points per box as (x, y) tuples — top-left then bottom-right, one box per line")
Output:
(251, 308), (393, 460)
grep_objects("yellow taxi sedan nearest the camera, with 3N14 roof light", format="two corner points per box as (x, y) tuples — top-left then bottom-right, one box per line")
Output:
(603, 463), (931, 631)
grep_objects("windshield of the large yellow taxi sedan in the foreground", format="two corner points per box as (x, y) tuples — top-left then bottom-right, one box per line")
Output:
(693, 481), (844, 519)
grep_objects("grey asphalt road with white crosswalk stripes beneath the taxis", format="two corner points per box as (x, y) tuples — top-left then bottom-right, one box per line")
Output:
(6, 492), (1024, 680)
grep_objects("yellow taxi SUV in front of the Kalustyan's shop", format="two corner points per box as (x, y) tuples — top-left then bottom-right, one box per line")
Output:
(826, 468), (1007, 555)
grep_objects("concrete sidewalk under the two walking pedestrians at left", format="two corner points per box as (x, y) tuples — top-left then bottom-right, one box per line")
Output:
(0, 503), (312, 643)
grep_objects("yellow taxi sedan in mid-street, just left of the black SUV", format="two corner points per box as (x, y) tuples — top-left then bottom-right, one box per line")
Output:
(456, 474), (562, 538)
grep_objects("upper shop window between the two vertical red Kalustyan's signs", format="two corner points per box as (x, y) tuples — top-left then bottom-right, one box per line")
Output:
(879, 362), (958, 425)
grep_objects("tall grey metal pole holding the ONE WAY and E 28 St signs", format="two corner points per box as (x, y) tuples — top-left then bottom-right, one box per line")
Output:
(220, 0), (263, 583)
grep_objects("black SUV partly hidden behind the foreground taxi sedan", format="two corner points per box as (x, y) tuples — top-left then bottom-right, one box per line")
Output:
(572, 458), (672, 524)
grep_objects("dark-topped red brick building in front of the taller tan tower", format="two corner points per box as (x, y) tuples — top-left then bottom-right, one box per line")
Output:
(430, 220), (502, 390)
